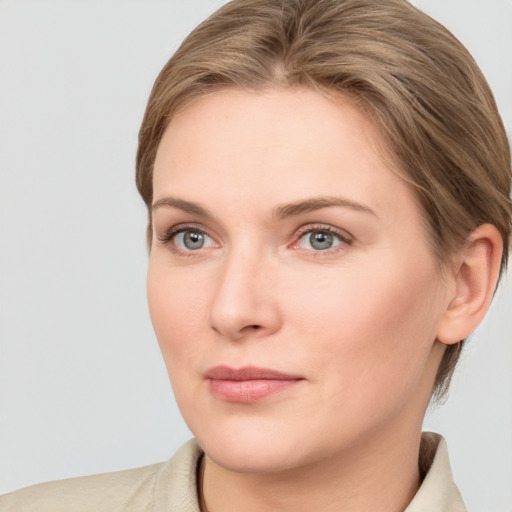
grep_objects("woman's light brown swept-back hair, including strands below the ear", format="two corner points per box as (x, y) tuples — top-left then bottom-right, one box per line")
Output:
(136, 0), (512, 398)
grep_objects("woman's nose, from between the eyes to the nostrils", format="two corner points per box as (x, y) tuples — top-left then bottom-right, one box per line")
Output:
(210, 250), (281, 340)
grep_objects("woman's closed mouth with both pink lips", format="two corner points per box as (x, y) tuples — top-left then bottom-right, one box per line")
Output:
(204, 366), (304, 404)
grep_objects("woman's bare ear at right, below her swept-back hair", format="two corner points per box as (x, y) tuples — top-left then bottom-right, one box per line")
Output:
(437, 224), (503, 345)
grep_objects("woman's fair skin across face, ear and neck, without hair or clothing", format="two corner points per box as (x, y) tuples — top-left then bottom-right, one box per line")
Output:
(148, 89), (500, 512)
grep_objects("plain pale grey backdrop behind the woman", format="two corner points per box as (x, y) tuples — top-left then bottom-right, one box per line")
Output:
(0, 0), (512, 512)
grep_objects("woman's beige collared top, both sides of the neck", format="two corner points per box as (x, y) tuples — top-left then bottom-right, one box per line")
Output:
(0, 433), (466, 512)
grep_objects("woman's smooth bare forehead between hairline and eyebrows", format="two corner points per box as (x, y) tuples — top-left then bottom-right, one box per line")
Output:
(153, 89), (418, 222)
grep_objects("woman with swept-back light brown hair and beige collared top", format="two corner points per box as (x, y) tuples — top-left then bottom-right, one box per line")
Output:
(0, 0), (511, 512)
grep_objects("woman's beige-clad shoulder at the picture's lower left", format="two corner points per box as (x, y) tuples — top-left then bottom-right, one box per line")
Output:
(0, 441), (204, 512)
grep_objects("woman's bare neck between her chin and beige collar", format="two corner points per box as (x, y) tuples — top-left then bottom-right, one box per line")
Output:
(201, 429), (421, 512)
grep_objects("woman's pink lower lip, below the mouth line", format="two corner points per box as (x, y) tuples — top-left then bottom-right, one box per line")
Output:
(209, 379), (302, 404)
